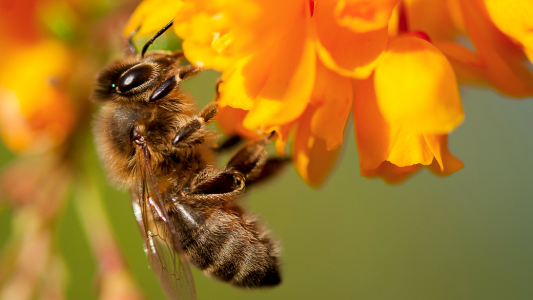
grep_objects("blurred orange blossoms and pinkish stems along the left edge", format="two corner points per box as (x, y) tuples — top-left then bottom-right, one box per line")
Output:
(0, 0), (142, 299)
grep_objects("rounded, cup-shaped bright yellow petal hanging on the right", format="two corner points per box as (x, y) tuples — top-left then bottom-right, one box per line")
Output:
(375, 36), (464, 133)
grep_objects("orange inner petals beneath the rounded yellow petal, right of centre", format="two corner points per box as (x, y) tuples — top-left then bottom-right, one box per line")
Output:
(353, 76), (462, 182)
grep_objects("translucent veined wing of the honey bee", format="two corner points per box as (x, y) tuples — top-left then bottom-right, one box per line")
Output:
(131, 151), (196, 300)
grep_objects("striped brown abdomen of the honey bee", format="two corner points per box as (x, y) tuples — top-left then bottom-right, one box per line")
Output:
(172, 199), (281, 287)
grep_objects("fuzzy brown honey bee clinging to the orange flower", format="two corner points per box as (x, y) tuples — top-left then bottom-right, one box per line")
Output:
(92, 21), (281, 299)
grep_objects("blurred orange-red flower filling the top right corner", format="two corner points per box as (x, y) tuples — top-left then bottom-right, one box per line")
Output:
(403, 0), (533, 97)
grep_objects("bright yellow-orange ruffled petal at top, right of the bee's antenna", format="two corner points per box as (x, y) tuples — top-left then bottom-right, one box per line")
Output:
(174, 0), (302, 70)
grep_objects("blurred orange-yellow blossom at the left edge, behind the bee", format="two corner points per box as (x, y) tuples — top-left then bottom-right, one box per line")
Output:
(0, 1), (75, 153)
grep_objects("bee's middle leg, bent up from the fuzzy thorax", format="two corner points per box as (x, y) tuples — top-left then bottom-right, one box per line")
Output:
(172, 102), (218, 148)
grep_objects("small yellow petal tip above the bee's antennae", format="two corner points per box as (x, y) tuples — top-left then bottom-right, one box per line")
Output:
(124, 0), (183, 36)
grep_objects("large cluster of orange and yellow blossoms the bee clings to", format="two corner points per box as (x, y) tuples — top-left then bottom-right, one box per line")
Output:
(125, 0), (533, 186)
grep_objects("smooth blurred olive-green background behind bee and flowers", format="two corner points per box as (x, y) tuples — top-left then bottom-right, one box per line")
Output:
(0, 66), (533, 299)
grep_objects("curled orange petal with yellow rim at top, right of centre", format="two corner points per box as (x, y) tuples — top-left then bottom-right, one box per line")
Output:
(313, 1), (388, 78)
